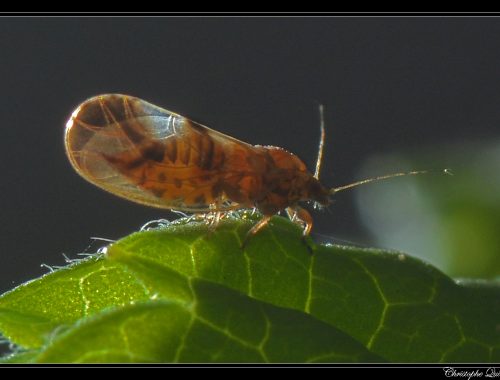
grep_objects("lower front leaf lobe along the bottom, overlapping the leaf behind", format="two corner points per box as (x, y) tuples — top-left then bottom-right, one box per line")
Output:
(33, 280), (380, 362)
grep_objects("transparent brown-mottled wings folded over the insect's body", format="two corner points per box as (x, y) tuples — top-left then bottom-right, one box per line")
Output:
(65, 94), (258, 212)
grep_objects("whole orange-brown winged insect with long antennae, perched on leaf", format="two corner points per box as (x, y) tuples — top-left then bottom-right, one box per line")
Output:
(64, 94), (434, 245)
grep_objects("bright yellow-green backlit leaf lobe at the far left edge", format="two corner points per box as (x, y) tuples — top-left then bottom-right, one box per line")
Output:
(0, 257), (149, 349)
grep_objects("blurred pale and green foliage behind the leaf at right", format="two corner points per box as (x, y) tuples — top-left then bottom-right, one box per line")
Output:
(356, 141), (500, 279)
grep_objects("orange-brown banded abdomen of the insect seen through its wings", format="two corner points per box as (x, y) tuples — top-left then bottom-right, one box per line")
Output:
(107, 125), (230, 207)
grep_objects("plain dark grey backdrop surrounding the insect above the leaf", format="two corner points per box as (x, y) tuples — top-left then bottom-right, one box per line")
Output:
(0, 17), (500, 292)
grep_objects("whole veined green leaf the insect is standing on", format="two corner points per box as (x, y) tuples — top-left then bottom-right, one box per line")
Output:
(0, 214), (500, 362)
